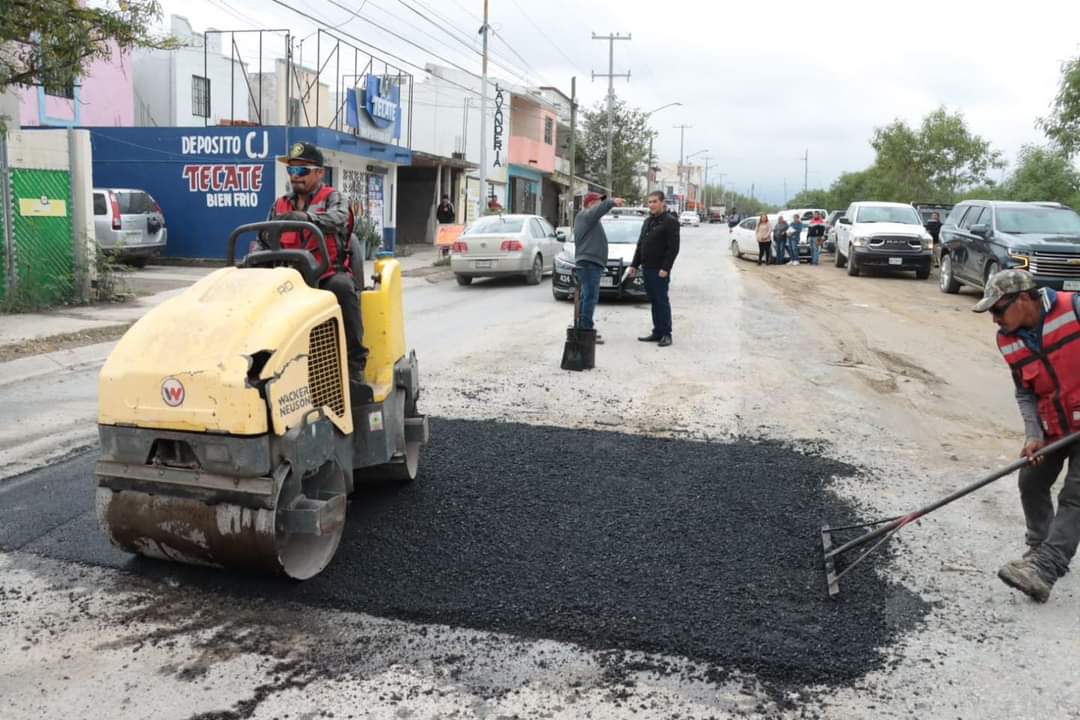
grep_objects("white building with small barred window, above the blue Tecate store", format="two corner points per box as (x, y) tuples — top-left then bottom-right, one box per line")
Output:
(132, 15), (248, 127)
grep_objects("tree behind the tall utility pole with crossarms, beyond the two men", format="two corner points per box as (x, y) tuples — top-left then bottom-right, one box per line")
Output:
(580, 99), (652, 203)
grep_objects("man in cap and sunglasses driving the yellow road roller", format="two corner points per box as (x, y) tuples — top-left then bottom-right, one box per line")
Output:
(270, 142), (367, 383)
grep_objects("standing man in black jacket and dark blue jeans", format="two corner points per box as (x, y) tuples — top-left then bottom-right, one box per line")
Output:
(627, 191), (679, 348)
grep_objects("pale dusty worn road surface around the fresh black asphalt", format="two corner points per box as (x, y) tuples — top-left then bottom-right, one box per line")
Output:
(0, 226), (1080, 718)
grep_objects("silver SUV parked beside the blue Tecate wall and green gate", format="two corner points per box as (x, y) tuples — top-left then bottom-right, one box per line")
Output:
(94, 188), (168, 268)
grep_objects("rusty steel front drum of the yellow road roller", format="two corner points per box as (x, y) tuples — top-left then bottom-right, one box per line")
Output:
(97, 462), (347, 580)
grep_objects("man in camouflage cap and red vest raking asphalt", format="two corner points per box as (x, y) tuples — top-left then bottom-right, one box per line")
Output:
(974, 270), (1080, 602)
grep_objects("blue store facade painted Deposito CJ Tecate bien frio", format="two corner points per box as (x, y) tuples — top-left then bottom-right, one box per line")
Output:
(90, 126), (411, 259)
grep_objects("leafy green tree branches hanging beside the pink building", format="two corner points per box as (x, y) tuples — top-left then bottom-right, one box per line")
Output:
(0, 0), (177, 103)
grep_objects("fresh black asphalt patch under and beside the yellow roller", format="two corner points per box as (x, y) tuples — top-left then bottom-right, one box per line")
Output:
(0, 419), (927, 692)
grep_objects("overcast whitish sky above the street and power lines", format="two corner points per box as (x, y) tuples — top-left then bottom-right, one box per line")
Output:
(162, 0), (1080, 203)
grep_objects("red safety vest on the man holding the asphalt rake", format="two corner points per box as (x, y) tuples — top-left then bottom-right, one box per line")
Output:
(998, 293), (1080, 440)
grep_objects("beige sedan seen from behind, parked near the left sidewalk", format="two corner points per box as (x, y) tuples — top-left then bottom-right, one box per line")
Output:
(450, 215), (563, 285)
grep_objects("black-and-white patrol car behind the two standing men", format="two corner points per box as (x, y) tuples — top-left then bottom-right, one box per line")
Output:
(551, 215), (646, 300)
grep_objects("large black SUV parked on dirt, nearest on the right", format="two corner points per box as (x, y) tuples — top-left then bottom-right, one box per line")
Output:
(941, 200), (1080, 293)
